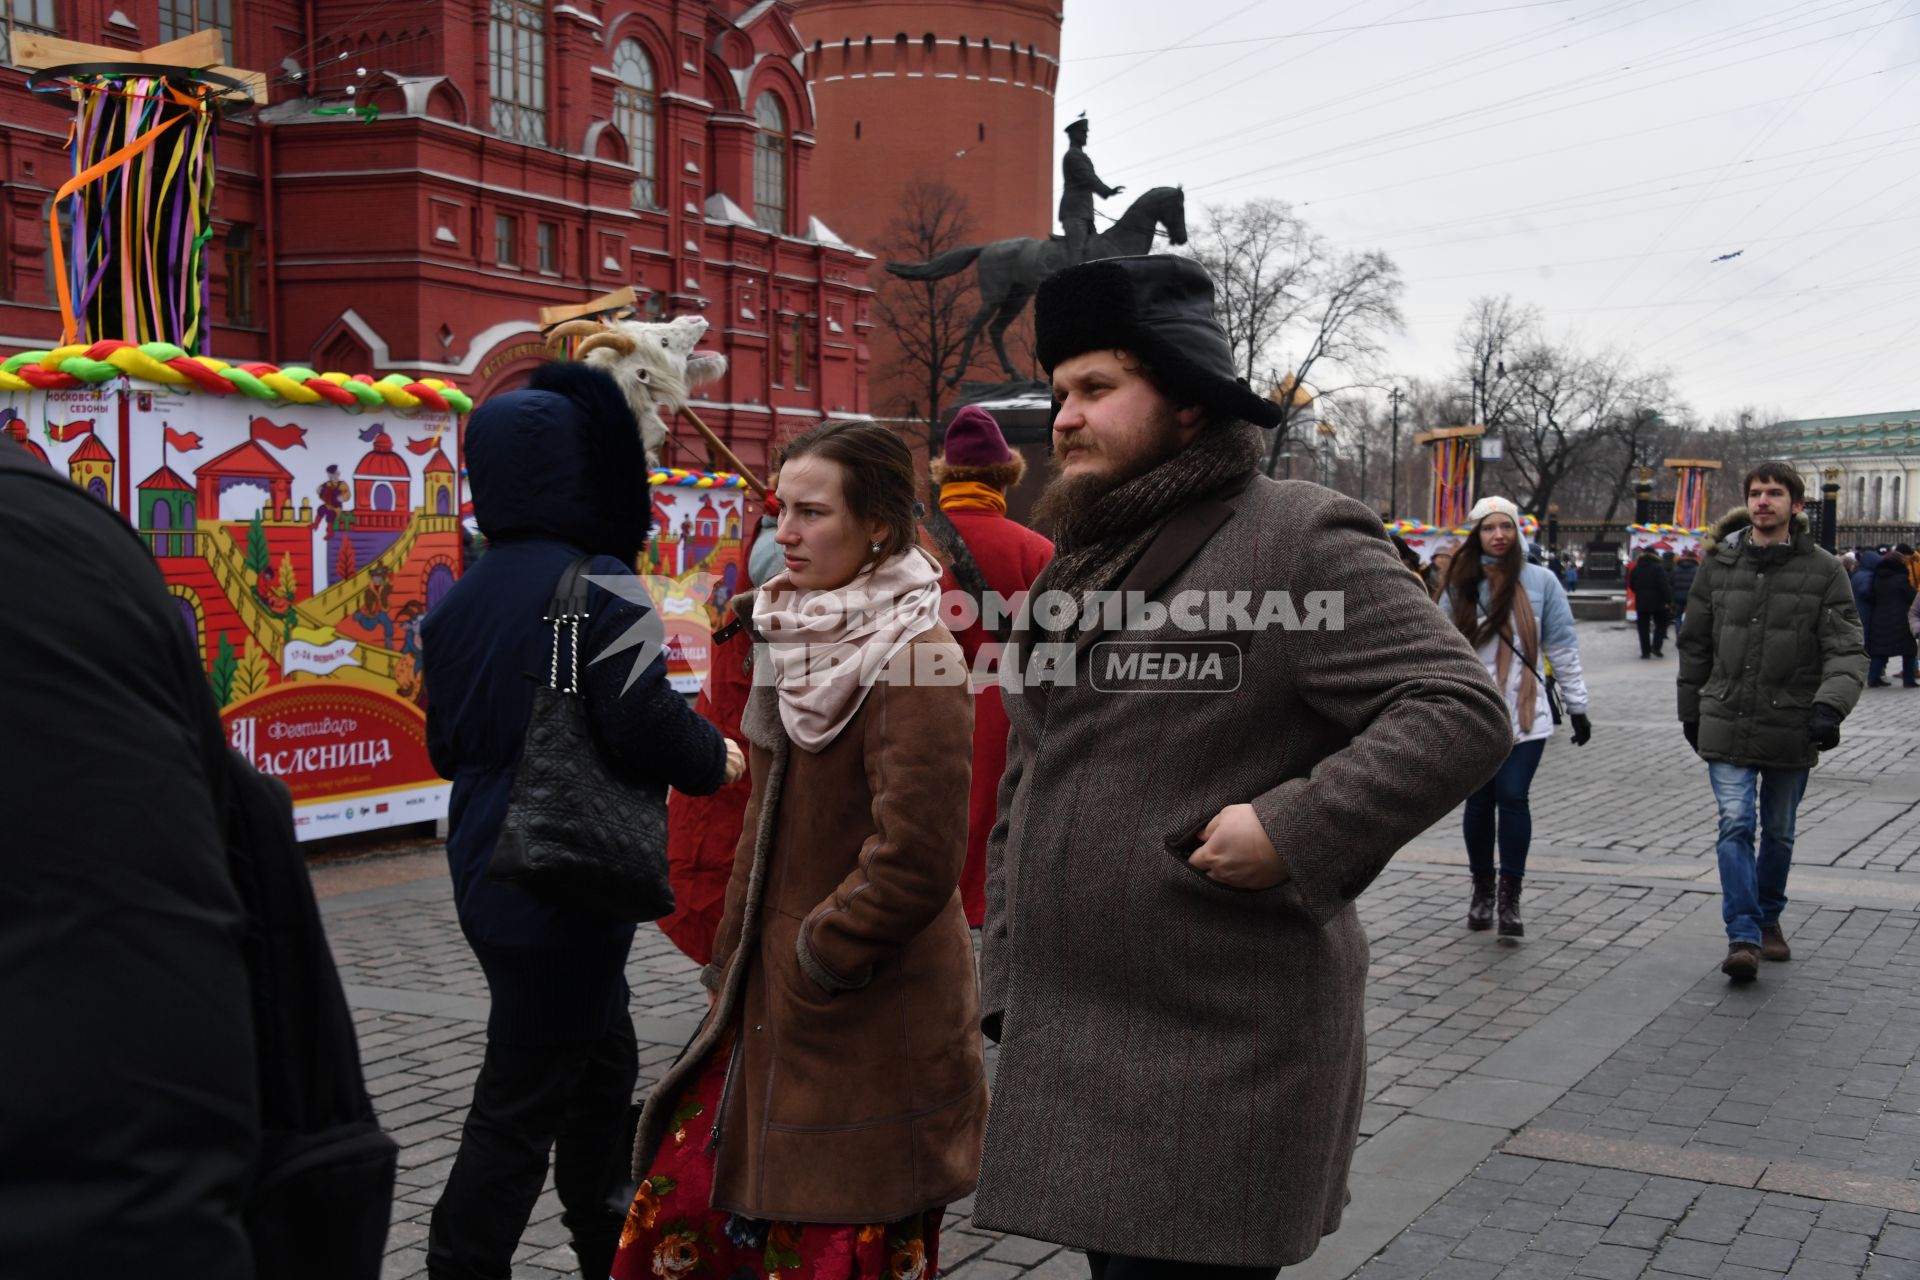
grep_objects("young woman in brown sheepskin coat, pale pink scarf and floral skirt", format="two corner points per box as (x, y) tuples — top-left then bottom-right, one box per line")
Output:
(614, 422), (987, 1280)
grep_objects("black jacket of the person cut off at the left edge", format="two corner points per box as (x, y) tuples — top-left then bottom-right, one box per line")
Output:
(0, 439), (259, 1280)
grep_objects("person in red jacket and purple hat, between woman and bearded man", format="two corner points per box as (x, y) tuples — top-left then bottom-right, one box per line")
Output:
(927, 405), (1054, 927)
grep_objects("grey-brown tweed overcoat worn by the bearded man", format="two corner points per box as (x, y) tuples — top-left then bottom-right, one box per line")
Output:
(975, 478), (1513, 1267)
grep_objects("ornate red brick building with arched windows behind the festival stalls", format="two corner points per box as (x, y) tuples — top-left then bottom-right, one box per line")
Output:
(0, 0), (872, 466)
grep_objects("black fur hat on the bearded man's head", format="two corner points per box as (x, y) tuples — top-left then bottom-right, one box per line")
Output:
(1033, 253), (1281, 426)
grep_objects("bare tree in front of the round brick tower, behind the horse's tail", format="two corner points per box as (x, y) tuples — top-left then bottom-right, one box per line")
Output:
(874, 177), (977, 453)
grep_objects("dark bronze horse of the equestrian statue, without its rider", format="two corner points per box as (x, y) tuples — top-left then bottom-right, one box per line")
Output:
(887, 186), (1187, 386)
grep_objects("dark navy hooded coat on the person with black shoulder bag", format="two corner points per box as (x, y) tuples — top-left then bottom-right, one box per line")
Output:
(420, 365), (726, 1044)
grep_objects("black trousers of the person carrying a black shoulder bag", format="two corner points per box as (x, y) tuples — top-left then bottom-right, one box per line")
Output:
(426, 1013), (639, 1280)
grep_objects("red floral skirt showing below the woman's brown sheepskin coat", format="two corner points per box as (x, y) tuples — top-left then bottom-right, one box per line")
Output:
(612, 1036), (943, 1280)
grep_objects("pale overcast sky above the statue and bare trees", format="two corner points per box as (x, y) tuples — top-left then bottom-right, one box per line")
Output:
(1058, 0), (1920, 427)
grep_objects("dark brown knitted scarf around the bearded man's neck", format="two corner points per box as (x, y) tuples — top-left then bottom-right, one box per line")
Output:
(1029, 422), (1260, 641)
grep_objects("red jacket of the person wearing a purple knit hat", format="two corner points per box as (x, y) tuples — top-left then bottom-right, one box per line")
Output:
(941, 507), (1054, 925)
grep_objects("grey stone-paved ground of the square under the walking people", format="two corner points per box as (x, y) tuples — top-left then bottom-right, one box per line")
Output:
(323, 624), (1920, 1280)
